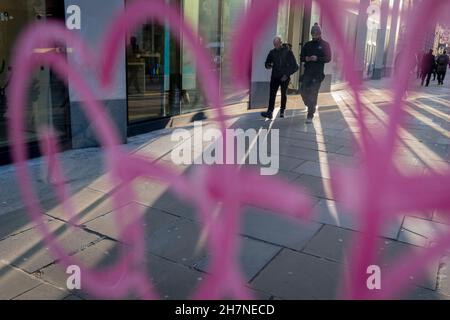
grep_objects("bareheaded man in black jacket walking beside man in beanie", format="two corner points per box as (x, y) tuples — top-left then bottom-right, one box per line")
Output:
(261, 36), (298, 119)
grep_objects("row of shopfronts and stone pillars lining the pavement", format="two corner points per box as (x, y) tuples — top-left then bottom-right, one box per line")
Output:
(0, 0), (410, 164)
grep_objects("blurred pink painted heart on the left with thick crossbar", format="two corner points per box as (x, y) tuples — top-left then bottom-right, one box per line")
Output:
(9, 0), (311, 299)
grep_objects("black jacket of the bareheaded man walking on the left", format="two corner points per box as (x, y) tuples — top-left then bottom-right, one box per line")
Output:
(265, 45), (298, 79)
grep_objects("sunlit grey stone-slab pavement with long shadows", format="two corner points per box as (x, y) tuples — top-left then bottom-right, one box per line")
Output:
(0, 81), (450, 299)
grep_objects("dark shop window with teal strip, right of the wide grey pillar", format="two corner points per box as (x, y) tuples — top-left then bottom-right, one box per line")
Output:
(126, 0), (181, 123)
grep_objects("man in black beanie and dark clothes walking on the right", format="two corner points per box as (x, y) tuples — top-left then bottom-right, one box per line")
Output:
(300, 23), (331, 123)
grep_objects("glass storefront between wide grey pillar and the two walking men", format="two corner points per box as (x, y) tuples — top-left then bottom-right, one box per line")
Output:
(127, 0), (248, 123)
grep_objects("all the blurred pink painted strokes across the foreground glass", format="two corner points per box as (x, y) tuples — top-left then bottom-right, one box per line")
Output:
(8, 0), (450, 299)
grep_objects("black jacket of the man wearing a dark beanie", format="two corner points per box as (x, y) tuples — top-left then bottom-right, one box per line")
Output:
(300, 39), (331, 81)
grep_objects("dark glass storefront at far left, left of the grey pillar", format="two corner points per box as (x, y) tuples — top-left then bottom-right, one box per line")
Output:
(0, 0), (70, 149)
